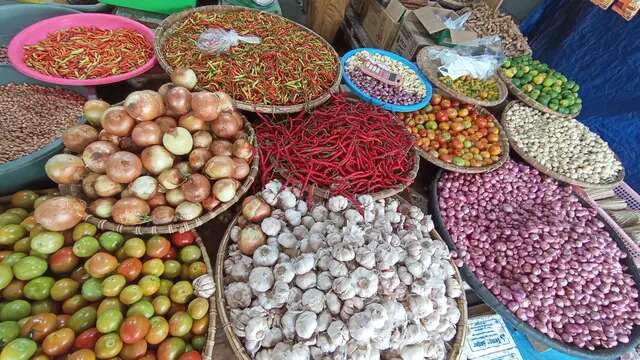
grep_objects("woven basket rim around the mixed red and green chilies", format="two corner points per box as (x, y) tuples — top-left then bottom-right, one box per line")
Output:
(153, 5), (342, 114)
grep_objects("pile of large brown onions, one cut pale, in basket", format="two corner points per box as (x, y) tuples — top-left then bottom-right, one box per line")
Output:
(45, 76), (255, 228)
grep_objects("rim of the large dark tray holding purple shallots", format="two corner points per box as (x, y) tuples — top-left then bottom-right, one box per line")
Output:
(428, 170), (640, 359)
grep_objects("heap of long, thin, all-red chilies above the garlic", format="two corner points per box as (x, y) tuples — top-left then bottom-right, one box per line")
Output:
(256, 95), (415, 197)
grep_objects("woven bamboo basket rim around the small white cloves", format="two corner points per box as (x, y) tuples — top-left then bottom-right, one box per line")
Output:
(500, 100), (625, 189)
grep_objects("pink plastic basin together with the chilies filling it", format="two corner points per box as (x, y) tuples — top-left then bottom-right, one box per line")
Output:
(8, 14), (155, 86)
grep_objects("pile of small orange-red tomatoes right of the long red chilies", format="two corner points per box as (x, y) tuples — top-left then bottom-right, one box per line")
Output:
(398, 94), (506, 167)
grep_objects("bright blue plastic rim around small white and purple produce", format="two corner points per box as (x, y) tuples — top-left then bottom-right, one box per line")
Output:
(340, 48), (433, 112)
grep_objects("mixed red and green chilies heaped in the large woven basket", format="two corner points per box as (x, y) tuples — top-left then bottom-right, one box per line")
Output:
(162, 10), (339, 105)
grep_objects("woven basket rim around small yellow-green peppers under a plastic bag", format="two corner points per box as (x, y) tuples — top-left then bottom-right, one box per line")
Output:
(416, 46), (509, 107)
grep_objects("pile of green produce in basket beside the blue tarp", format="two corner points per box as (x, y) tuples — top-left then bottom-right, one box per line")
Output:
(501, 55), (582, 115)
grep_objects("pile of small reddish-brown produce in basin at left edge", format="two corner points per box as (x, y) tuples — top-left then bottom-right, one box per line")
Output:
(0, 84), (86, 164)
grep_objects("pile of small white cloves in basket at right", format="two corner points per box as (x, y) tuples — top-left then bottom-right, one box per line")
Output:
(503, 103), (623, 184)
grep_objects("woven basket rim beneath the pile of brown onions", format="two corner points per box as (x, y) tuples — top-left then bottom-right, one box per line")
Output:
(58, 118), (259, 235)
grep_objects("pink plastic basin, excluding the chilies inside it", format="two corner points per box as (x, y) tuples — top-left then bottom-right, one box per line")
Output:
(7, 14), (156, 86)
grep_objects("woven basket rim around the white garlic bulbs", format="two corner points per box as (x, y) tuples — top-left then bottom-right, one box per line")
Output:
(215, 208), (468, 360)
